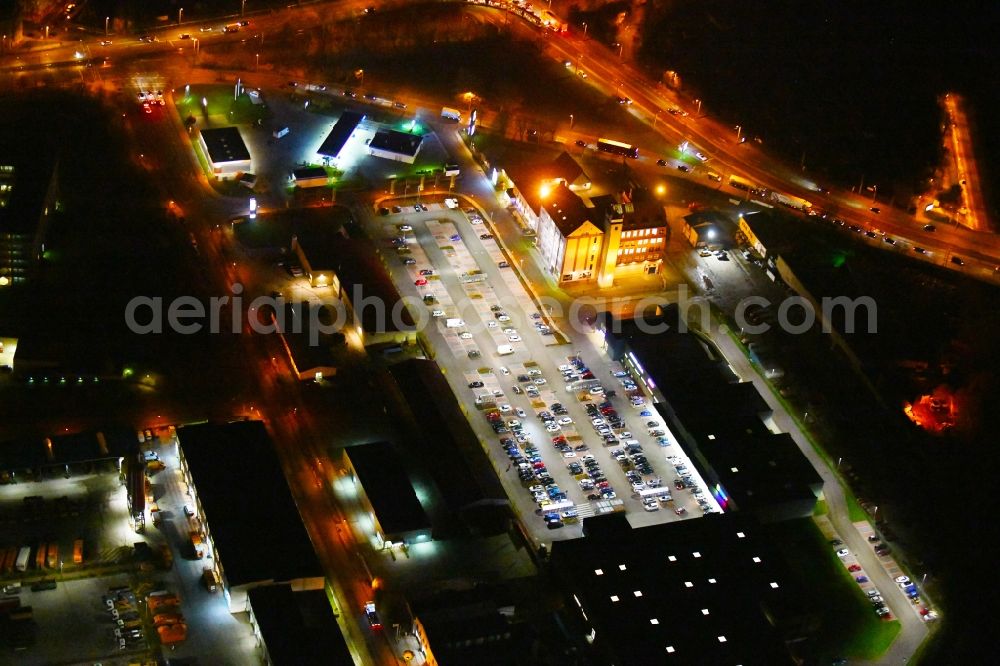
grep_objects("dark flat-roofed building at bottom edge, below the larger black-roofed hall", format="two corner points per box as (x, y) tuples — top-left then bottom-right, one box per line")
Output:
(247, 584), (354, 666)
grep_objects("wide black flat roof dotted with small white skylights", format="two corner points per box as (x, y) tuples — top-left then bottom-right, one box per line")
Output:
(550, 514), (796, 666)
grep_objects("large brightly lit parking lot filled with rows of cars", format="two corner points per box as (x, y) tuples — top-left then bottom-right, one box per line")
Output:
(372, 200), (719, 541)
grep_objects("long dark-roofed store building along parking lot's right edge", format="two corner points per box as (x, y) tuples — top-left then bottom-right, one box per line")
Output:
(598, 307), (823, 522)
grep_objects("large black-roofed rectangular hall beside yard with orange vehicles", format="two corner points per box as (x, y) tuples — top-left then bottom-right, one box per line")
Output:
(177, 421), (324, 613)
